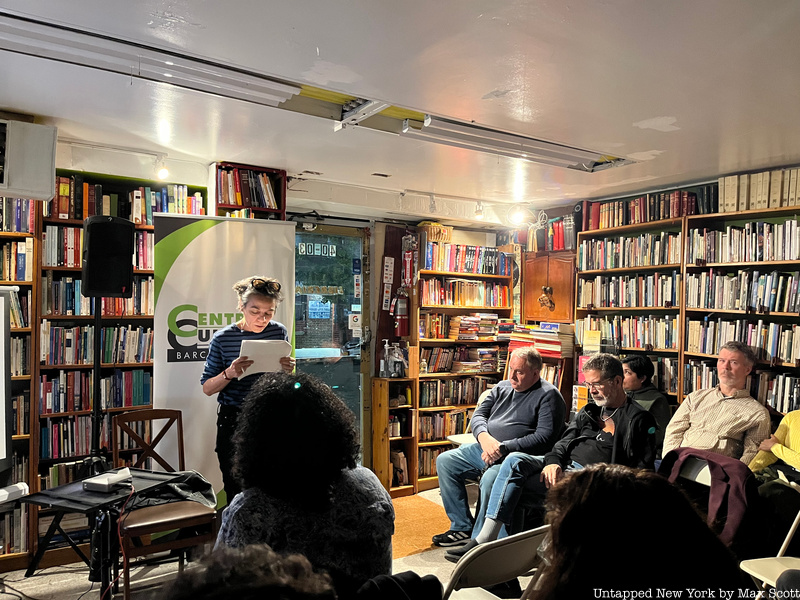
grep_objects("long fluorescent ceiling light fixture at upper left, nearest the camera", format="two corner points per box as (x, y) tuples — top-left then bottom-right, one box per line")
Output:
(0, 13), (300, 106)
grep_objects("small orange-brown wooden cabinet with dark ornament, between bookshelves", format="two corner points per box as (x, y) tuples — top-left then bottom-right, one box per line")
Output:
(522, 252), (575, 323)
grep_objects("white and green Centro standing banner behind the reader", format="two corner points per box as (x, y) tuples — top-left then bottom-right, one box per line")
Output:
(153, 214), (295, 492)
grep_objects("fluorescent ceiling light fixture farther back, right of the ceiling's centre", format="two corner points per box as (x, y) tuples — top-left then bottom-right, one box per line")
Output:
(400, 117), (633, 172)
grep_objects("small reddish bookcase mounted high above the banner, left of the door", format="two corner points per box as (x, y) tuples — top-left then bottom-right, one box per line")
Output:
(209, 162), (287, 221)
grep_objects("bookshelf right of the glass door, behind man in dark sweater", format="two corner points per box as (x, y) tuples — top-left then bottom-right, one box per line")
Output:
(409, 231), (513, 492)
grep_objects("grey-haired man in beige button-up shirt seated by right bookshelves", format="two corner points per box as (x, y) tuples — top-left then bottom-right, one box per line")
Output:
(663, 342), (770, 465)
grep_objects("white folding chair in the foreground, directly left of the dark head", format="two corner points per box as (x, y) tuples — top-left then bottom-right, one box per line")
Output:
(442, 525), (550, 600)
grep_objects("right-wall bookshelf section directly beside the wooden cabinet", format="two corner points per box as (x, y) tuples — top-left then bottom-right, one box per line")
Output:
(575, 218), (685, 402)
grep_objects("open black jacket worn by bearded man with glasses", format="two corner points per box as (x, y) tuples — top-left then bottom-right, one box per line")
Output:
(544, 400), (656, 469)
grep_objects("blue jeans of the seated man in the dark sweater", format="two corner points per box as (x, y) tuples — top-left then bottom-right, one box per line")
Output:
(436, 444), (500, 532)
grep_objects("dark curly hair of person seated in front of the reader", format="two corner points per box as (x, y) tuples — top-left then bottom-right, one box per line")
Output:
(233, 373), (360, 510)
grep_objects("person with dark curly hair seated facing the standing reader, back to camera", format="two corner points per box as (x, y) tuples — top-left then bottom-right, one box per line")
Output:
(216, 373), (394, 596)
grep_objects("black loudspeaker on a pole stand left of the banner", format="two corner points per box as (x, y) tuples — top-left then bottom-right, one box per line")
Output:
(81, 215), (136, 460)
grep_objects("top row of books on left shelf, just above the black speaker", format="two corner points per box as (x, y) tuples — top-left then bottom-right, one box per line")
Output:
(49, 173), (205, 225)
